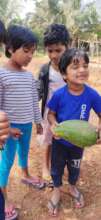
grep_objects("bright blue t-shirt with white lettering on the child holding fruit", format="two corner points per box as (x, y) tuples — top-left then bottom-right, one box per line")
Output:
(47, 85), (101, 147)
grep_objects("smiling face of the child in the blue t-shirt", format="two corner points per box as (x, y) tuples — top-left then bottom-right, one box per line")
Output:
(65, 57), (89, 85)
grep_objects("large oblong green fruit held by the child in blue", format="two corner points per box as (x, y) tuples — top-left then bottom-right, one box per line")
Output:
(54, 120), (98, 148)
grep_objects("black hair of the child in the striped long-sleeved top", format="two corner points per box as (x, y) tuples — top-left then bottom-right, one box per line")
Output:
(5, 25), (37, 57)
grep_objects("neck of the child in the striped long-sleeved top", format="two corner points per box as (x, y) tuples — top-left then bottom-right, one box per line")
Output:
(5, 59), (23, 71)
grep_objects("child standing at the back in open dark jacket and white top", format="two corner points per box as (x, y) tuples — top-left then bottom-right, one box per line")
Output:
(39, 24), (70, 183)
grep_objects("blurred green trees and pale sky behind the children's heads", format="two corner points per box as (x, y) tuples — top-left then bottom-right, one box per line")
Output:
(0, 0), (101, 49)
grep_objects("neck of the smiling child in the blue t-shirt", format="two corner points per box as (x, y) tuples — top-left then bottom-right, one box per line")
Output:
(68, 83), (84, 95)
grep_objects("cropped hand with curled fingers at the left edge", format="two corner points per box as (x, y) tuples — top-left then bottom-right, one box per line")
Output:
(0, 111), (10, 149)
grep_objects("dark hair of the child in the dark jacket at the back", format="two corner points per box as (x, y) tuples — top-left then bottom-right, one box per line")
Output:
(43, 24), (70, 47)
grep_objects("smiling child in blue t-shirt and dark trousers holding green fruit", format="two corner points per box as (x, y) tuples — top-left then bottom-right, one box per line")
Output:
(48, 48), (101, 216)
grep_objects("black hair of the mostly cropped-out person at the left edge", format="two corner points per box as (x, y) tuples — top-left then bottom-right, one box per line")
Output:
(0, 20), (6, 43)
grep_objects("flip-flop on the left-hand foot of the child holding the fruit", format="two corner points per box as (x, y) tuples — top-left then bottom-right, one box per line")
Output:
(47, 200), (60, 217)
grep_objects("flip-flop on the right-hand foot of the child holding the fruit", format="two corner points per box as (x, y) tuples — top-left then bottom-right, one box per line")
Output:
(72, 191), (84, 208)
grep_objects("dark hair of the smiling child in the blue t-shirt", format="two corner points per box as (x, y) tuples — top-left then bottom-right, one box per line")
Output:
(59, 48), (89, 75)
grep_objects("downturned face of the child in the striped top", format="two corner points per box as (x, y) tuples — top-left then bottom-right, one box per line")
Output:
(10, 46), (36, 67)
